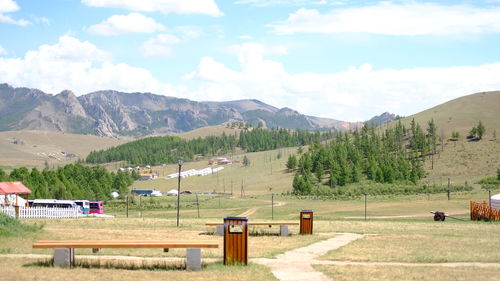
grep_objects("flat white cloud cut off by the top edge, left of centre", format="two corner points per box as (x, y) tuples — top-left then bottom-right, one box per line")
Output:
(82, 0), (223, 17)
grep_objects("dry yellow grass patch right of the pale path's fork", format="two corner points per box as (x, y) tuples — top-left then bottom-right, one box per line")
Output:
(323, 218), (500, 263)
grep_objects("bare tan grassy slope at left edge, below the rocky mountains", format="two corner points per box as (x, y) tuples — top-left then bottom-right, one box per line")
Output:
(0, 131), (125, 167)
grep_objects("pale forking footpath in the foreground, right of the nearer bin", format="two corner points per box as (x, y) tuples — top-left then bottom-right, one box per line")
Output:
(252, 233), (363, 281)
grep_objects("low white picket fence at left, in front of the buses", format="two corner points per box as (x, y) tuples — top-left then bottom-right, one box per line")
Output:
(0, 206), (84, 219)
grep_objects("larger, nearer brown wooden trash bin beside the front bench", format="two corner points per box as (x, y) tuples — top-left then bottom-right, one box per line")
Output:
(224, 217), (248, 265)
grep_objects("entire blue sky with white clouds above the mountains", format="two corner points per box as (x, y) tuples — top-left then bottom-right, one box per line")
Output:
(0, 0), (500, 121)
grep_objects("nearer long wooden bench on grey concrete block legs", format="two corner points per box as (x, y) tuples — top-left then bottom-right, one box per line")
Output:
(33, 240), (219, 270)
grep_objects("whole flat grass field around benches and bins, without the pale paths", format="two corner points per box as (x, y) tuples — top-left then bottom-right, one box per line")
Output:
(0, 190), (500, 280)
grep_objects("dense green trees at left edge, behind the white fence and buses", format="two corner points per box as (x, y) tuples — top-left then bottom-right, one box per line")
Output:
(0, 164), (139, 201)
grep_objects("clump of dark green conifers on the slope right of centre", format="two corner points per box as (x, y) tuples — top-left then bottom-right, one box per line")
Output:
(287, 120), (437, 195)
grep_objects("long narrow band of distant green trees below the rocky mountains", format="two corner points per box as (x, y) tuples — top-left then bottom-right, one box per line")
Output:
(85, 128), (332, 165)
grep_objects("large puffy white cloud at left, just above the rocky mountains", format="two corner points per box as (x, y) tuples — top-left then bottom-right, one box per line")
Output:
(0, 35), (177, 95)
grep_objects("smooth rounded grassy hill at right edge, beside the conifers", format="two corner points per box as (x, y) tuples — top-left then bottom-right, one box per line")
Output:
(381, 91), (500, 185)
